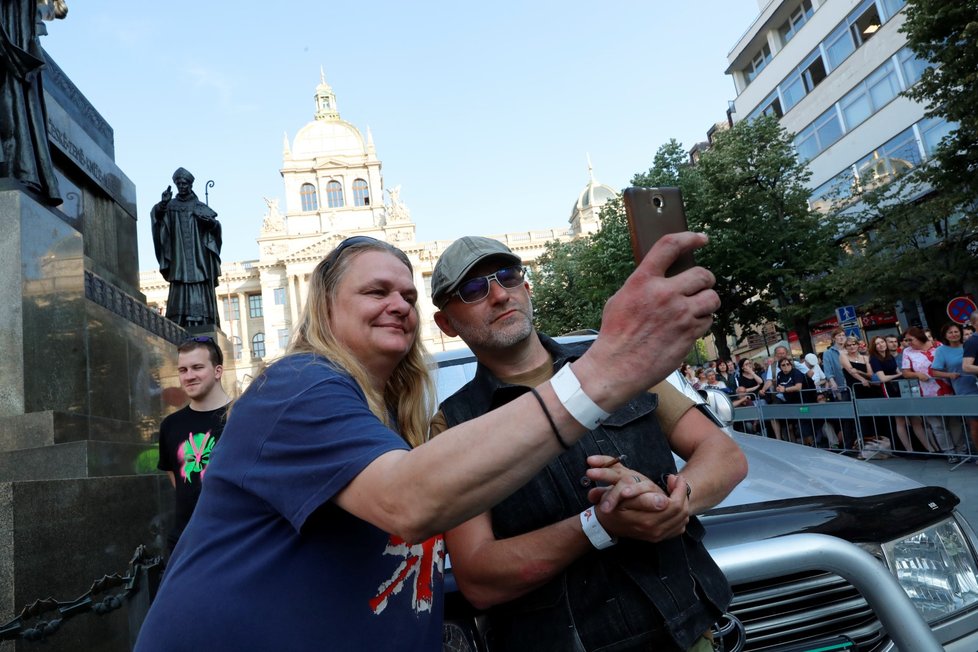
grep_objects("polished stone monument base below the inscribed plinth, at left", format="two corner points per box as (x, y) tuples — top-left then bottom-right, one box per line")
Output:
(0, 185), (181, 652)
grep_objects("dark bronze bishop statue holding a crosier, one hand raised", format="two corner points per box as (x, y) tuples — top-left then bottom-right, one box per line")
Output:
(153, 168), (221, 328)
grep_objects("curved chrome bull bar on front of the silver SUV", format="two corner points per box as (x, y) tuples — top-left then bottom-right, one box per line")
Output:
(710, 534), (944, 652)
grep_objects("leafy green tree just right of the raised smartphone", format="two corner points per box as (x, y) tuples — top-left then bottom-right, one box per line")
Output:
(684, 116), (837, 356)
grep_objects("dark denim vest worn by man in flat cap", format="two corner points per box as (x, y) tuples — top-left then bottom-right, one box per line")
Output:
(441, 336), (731, 652)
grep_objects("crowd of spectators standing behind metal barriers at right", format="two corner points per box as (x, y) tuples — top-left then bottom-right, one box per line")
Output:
(680, 313), (978, 464)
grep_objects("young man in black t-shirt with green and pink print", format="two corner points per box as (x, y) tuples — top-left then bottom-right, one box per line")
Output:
(157, 337), (230, 558)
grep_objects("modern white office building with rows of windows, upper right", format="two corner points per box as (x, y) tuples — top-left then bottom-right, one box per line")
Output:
(726, 0), (949, 348)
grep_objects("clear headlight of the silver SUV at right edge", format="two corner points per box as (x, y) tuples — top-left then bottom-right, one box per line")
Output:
(883, 519), (978, 623)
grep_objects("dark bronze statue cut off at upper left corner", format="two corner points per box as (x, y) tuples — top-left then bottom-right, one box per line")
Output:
(0, 0), (67, 206)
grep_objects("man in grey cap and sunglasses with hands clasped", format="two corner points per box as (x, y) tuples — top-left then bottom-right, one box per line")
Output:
(431, 237), (747, 652)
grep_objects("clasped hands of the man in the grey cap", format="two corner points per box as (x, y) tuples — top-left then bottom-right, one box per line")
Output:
(586, 455), (691, 543)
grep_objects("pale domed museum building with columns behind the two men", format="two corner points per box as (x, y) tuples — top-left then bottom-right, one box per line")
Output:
(140, 76), (618, 390)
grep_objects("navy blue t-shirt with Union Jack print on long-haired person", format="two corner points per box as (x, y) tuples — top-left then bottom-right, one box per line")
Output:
(136, 354), (444, 652)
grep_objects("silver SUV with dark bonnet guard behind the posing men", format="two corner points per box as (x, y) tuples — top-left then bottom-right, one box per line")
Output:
(435, 338), (978, 652)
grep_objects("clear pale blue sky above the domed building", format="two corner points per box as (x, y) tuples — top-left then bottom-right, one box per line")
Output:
(42, 0), (758, 270)
